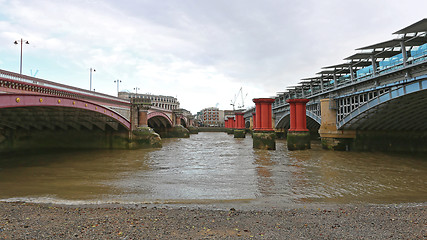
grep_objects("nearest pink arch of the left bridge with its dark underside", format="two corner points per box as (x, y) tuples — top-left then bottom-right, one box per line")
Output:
(0, 94), (131, 131)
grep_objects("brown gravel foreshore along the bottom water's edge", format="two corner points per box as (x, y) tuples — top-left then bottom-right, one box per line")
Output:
(0, 202), (427, 239)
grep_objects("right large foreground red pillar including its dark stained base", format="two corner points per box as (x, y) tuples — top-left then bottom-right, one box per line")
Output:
(286, 99), (311, 150)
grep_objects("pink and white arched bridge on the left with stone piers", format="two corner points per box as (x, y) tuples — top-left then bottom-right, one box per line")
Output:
(0, 70), (192, 151)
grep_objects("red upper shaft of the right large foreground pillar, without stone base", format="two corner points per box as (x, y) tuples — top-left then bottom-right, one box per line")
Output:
(286, 99), (309, 132)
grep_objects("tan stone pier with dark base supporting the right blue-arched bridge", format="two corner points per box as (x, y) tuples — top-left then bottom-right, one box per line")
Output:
(319, 98), (356, 150)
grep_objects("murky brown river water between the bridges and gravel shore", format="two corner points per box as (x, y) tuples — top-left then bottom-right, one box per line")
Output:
(0, 133), (427, 206)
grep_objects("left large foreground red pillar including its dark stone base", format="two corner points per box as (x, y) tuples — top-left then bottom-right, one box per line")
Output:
(252, 98), (276, 150)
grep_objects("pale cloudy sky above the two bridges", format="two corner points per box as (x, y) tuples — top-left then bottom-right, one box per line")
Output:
(0, 0), (427, 113)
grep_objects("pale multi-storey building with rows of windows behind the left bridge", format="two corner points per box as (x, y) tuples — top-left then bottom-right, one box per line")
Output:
(119, 92), (179, 111)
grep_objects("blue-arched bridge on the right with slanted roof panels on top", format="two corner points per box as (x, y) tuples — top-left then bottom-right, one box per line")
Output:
(272, 19), (427, 151)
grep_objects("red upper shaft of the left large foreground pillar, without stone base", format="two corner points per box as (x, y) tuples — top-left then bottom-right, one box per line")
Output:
(252, 98), (274, 131)
